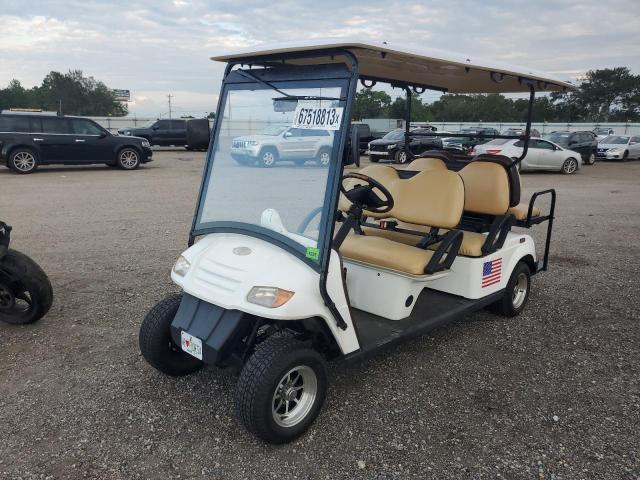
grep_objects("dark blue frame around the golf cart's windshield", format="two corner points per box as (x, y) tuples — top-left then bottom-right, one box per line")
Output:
(190, 64), (357, 272)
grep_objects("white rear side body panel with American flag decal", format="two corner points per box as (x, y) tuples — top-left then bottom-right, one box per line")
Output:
(429, 232), (537, 299)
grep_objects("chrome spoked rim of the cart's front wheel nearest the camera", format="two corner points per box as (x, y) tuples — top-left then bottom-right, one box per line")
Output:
(271, 365), (318, 427)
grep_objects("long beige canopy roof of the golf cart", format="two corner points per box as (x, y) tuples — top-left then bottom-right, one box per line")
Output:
(212, 39), (575, 93)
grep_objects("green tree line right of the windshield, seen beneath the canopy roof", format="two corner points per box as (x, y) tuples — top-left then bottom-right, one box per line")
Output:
(354, 67), (640, 122)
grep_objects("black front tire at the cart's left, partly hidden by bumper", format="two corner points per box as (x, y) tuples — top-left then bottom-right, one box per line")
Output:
(138, 294), (204, 377)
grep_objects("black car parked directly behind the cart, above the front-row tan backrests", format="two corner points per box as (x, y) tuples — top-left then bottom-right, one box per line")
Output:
(366, 128), (442, 164)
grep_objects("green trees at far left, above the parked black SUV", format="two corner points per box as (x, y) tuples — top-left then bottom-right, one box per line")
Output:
(0, 70), (127, 117)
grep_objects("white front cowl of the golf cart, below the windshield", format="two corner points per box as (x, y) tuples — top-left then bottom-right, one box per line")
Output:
(171, 233), (359, 354)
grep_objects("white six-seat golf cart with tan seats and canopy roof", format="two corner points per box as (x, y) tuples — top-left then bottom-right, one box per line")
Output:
(140, 42), (572, 443)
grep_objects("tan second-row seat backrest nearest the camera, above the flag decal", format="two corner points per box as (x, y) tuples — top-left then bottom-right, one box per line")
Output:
(458, 161), (510, 215)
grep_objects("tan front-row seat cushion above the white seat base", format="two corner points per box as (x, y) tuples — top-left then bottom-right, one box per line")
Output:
(340, 235), (433, 275)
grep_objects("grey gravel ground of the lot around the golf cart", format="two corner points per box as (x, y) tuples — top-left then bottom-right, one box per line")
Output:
(0, 151), (640, 479)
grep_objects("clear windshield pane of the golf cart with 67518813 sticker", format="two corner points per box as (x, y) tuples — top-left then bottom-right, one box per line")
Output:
(194, 80), (345, 262)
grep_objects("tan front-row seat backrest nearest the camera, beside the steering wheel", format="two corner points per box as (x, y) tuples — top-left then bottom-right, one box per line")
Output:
(389, 170), (465, 228)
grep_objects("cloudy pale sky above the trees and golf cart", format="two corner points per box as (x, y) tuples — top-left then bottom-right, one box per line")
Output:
(0, 0), (640, 118)
